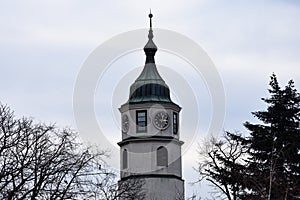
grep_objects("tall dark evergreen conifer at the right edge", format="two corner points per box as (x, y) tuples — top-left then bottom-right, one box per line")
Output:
(244, 74), (300, 199)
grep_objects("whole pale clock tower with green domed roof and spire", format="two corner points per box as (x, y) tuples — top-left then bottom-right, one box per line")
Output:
(118, 13), (184, 200)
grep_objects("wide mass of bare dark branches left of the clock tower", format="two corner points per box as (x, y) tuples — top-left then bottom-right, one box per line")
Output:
(0, 103), (143, 199)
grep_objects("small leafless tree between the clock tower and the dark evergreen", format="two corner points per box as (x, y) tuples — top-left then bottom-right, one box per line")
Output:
(198, 132), (247, 200)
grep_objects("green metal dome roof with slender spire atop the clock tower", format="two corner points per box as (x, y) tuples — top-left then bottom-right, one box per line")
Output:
(129, 14), (172, 103)
